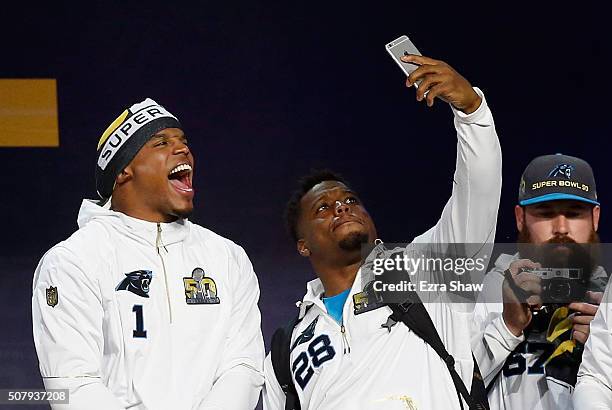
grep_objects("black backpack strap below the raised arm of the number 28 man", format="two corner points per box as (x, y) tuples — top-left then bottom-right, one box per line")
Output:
(389, 294), (489, 410)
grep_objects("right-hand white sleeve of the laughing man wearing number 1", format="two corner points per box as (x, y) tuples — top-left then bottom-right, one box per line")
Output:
(199, 248), (264, 410)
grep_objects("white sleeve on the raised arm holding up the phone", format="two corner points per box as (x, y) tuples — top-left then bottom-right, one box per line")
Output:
(414, 88), (502, 245)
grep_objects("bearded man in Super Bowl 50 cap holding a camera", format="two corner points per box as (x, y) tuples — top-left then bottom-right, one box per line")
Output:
(473, 154), (608, 410)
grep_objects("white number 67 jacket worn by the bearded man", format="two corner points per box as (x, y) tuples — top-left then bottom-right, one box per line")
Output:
(472, 254), (607, 410)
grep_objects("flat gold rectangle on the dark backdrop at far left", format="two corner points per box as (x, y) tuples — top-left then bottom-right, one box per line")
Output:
(0, 78), (59, 147)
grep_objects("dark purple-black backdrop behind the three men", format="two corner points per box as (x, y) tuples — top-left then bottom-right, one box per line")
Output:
(0, 1), (612, 400)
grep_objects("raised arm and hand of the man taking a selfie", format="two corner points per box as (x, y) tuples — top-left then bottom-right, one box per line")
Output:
(403, 55), (501, 243)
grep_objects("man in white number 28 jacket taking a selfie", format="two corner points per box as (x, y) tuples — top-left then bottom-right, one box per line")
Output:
(263, 56), (501, 410)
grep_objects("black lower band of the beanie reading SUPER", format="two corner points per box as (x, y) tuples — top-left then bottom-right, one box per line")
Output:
(96, 117), (182, 199)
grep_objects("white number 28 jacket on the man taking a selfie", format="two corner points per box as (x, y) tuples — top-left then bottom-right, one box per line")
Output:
(263, 89), (501, 410)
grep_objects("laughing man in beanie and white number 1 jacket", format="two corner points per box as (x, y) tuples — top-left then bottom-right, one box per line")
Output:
(32, 99), (264, 410)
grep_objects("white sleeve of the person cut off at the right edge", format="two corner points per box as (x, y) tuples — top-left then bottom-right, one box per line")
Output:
(572, 282), (612, 410)
